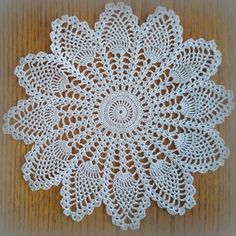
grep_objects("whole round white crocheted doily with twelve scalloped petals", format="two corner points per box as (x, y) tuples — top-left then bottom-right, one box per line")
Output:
(3, 3), (234, 229)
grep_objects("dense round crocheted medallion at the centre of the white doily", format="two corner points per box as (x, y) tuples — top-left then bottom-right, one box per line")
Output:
(99, 91), (142, 133)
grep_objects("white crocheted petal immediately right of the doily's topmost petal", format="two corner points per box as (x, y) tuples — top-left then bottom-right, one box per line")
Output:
(141, 7), (183, 62)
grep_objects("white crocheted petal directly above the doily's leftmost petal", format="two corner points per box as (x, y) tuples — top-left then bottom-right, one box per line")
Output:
(15, 52), (76, 96)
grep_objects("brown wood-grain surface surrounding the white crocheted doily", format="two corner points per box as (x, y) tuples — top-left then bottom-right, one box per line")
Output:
(0, 0), (236, 236)
